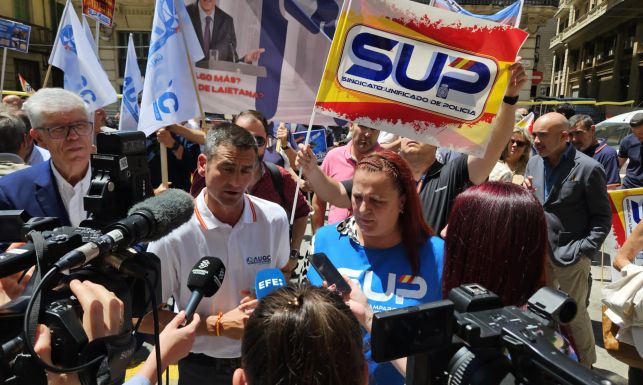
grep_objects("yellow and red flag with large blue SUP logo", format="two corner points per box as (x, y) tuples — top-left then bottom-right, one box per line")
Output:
(315, 0), (528, 155)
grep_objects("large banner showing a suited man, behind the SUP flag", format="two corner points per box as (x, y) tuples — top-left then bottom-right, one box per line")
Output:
(185, 0), (342, 124)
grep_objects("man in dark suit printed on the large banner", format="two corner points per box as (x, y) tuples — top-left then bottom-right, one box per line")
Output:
(186, 0), (264, 64)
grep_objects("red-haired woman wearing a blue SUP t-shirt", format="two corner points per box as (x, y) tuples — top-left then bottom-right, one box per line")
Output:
(308, 151), (444, 385)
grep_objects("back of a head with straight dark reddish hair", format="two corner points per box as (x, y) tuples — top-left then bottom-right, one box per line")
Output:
(442, 182), (547, 306)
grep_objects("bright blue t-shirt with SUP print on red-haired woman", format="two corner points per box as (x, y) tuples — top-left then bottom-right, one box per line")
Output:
(308, 224), (444, 385)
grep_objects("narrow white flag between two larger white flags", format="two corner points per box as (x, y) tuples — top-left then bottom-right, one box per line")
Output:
(118, 33), (143, 131)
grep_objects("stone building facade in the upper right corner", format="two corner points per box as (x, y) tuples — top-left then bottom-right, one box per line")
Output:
(549, 0), (643, 105)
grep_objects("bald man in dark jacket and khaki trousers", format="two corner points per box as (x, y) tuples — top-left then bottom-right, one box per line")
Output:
(525, 112), (612, 367)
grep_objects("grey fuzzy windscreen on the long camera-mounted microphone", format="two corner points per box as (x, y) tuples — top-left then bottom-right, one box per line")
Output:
(128, 188), (194, 242)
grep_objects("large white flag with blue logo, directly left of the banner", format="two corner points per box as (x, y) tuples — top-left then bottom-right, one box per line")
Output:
(138, 0), (203, 135)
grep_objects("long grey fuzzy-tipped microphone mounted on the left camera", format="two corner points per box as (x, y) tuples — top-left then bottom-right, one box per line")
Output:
(54, 189), (194, 270)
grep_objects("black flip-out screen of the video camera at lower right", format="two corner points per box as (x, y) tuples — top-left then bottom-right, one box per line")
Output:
(371, 300), (454, 362)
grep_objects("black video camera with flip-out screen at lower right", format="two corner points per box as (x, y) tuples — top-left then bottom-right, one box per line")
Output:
(371, 284), (611, 385)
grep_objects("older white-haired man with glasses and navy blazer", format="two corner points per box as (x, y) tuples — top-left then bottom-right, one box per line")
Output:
(0, 88), (93, 230)
